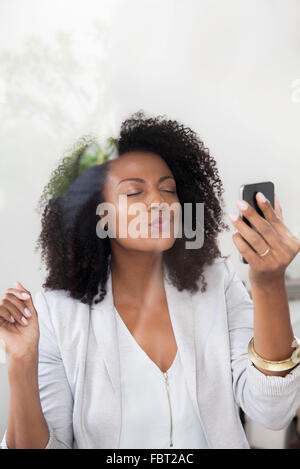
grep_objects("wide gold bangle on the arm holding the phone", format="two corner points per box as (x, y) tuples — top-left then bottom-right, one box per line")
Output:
(248, 337), (300, 371)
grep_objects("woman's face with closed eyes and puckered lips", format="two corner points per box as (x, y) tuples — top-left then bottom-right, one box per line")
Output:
(102, 151), (180, 251)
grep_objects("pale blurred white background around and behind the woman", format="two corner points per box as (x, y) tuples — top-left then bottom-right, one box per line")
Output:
(0, 0), (300, 448)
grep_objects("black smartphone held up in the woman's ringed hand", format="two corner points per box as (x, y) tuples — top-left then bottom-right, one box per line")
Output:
(239, 181), (274, 264)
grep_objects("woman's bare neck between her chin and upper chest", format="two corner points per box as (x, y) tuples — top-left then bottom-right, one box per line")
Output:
(110, 246), (165, 307)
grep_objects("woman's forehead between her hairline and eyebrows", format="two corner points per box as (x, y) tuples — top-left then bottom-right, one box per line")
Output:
(109, 151), (172, 180)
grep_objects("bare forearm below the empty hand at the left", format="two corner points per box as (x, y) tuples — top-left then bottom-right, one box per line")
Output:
(6, 357), (49, 449)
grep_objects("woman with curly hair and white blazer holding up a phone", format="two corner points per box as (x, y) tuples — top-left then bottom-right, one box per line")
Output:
(0, 112), (300, 448)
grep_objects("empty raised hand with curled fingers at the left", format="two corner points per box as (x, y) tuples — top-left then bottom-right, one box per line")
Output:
(0, 282), (40, 361)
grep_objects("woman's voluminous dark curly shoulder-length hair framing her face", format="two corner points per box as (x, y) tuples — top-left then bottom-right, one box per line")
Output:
(35, 110), (229, 305)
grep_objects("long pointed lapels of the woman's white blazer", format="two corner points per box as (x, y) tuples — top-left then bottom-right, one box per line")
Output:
(91, 262), (200, 418)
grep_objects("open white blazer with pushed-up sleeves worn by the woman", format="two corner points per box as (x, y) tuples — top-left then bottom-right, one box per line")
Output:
(2, 258), (300, 449)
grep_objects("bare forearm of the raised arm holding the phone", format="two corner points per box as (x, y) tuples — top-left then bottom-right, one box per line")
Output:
(251, 278), (295, 376)
